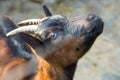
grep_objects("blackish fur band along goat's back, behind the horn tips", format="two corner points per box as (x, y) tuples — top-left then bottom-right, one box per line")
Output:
(0, 16), (31, 59)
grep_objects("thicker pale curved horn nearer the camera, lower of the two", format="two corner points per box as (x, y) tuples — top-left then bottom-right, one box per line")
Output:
(6, 25), (38, 37)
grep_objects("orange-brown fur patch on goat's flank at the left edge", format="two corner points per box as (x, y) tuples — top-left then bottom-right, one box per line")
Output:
(0, 39), (26, 80)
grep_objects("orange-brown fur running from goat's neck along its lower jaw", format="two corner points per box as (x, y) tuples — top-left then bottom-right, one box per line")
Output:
(29, 37), (91, 80)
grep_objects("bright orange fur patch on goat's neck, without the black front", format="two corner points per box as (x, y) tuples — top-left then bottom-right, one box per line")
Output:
(34, 58), (68, 80)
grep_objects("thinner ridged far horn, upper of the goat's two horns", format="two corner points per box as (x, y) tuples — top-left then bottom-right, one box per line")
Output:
(18, 17), (48, 27)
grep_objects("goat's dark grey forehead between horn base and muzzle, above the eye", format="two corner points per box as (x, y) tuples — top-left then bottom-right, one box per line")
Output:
(37, 15), (67, 32)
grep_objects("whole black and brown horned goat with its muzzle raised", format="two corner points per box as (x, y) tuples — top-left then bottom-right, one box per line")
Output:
(0, 6), (103, 80)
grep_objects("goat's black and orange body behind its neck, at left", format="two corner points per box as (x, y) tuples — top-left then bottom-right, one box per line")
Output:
(0, 15), (38, 80)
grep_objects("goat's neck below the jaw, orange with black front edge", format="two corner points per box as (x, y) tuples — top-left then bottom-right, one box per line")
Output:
(34, 58), (76, 80)
